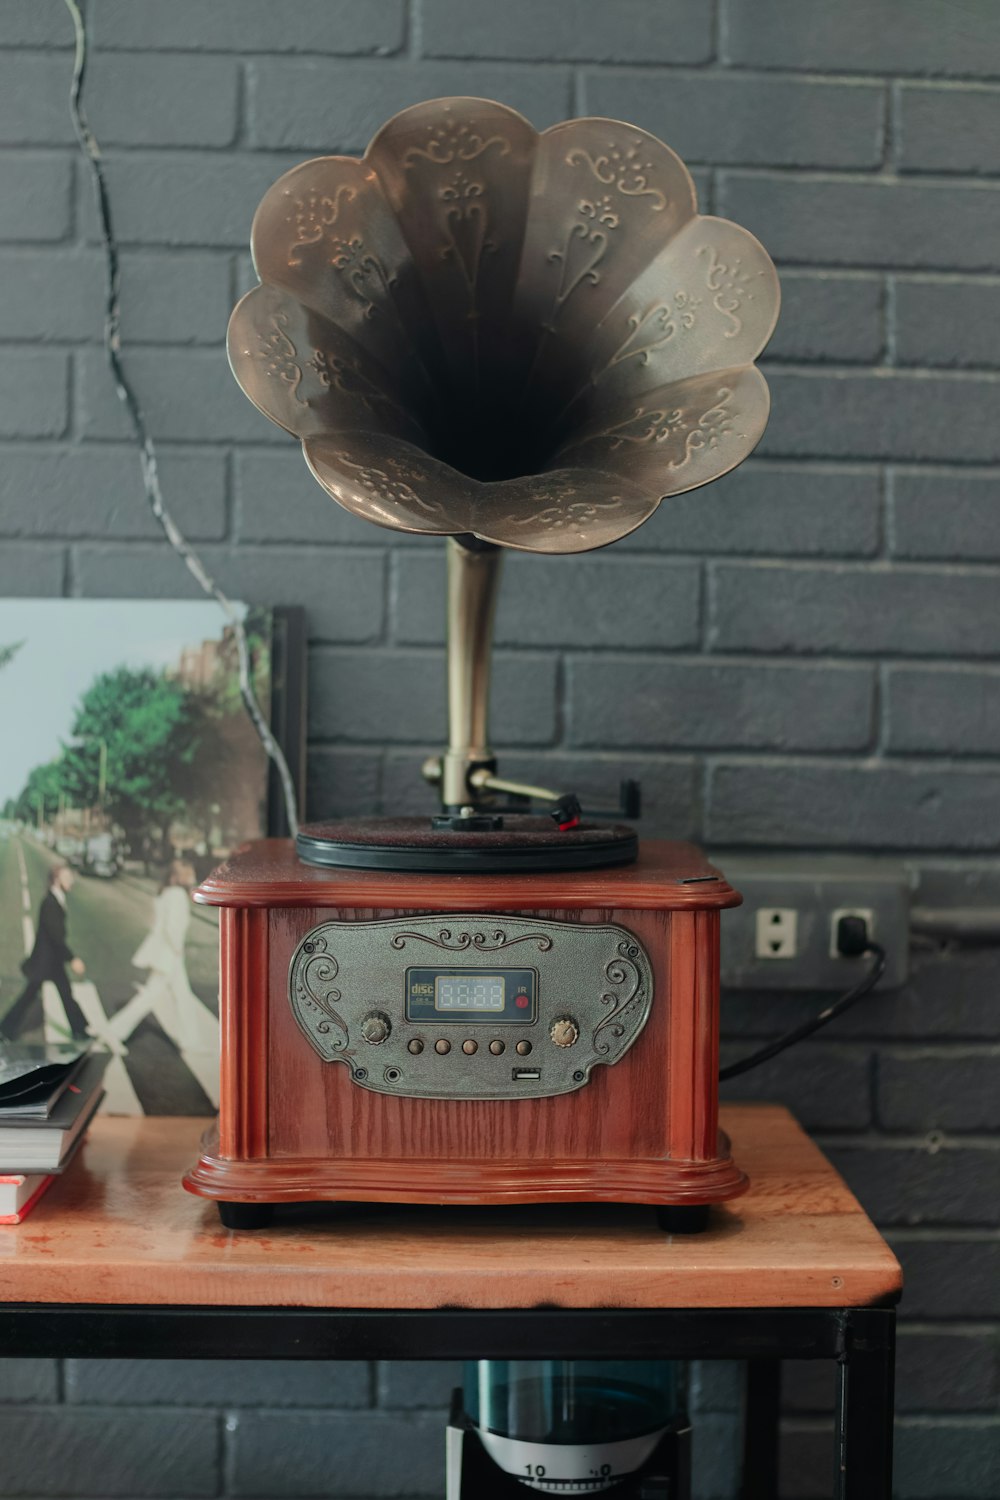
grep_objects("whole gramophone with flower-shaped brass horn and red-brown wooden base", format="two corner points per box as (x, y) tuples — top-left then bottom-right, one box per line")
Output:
(184, 99), (778, 1230)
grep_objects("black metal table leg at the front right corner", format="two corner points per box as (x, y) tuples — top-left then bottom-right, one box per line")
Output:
(834, 1308), (895, 1500)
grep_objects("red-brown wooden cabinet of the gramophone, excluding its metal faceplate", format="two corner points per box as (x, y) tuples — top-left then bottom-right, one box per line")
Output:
(187, 840), (747, 1203)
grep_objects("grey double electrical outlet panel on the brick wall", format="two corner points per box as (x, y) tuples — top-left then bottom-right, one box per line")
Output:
(712, 851), (910, 992)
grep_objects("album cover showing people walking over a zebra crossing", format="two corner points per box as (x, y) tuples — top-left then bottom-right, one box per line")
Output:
(0, 599), (296, 1115)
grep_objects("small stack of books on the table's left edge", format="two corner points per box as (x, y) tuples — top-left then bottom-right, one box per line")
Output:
(0, 1043), (108, 1224)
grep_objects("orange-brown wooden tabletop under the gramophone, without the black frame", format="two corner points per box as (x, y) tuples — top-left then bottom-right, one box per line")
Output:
(0, 1104), (901, 1310)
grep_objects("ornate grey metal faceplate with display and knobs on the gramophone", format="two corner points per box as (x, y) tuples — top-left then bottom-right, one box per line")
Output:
(288, 914), (652, 1100)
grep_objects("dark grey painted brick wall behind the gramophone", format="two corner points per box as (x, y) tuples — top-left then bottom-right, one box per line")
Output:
(0, 0), (1000, 1500)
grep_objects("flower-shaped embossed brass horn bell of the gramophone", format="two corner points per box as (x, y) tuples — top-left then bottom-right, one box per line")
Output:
(229, 99), (780, 552)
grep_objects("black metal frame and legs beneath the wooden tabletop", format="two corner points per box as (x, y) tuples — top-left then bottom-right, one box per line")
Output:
(0, 1302), (895, 1500)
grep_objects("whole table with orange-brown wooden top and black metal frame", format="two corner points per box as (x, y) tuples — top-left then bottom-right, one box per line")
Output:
(0, 1106), (901, 1500)
